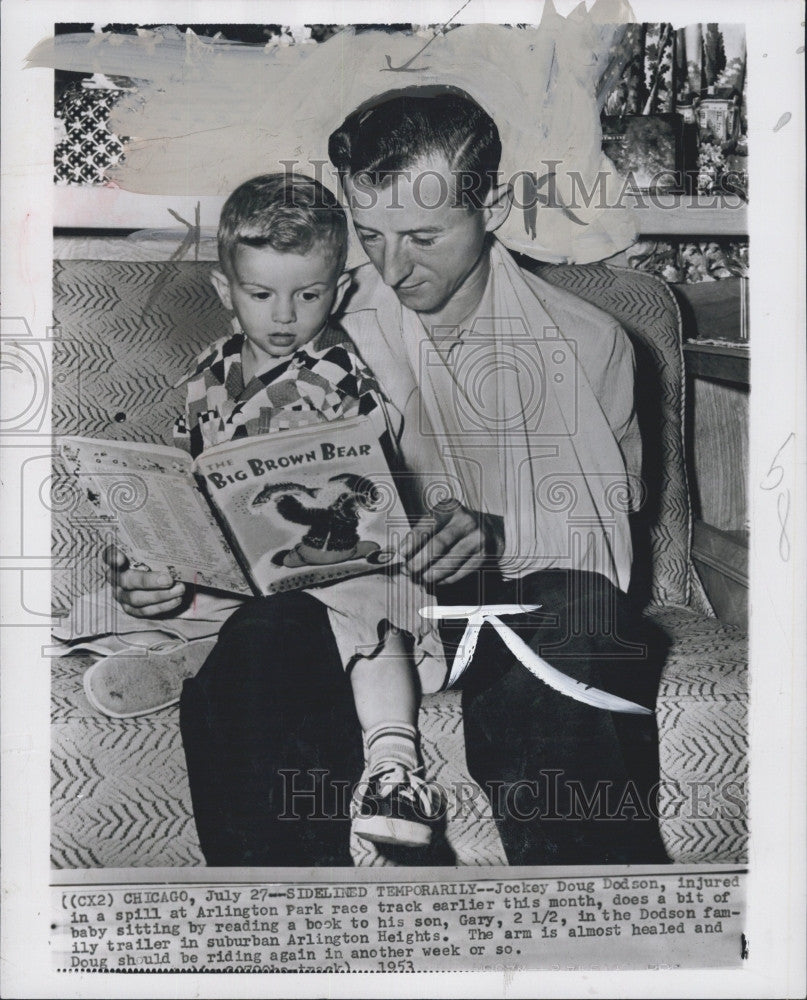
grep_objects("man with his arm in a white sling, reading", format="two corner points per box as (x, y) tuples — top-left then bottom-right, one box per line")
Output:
(107, 92), (663, 866)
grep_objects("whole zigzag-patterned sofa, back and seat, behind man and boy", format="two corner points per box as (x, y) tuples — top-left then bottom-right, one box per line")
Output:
(52, 261), (746, 868)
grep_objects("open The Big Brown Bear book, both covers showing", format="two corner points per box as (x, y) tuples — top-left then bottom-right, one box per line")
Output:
(59, 417), (408, 594)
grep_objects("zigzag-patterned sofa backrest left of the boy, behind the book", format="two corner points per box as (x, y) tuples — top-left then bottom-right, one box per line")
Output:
(52, 261), (230, 615)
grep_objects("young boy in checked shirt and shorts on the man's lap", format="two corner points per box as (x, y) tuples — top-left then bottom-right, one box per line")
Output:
(174, 174), (445, 846)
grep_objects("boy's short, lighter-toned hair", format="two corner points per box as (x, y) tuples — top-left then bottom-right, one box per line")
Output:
(218, 173), (347, 276)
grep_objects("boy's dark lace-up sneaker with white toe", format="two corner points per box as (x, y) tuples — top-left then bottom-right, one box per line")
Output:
(353, 764), (442, 847)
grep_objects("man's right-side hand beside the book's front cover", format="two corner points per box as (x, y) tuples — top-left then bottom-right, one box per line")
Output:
(400, 501), (504, 584)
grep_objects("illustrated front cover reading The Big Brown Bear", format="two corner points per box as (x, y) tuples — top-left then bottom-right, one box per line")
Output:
(195, 418), (409, 594)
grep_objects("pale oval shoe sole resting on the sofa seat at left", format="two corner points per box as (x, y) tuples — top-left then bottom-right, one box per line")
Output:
(84, 636), (216, 719)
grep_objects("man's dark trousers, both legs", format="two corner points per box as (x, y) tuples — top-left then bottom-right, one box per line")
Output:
(180, 570), (665, 867)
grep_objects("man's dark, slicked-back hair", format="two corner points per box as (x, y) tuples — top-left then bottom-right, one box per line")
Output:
(328, 90), (502, 208)
